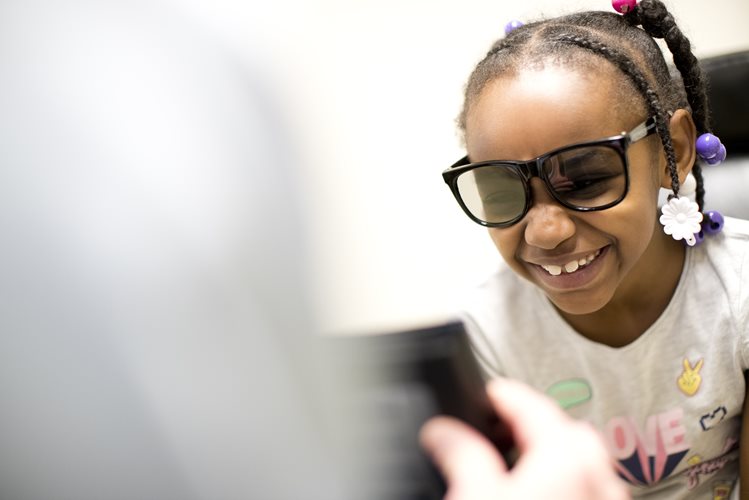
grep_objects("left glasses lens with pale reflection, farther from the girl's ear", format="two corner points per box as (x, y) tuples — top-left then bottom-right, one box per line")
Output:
(458, 165), (525, 224)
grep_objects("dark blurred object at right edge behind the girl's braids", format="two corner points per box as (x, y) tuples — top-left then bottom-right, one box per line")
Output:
(700, 50), (749, 155)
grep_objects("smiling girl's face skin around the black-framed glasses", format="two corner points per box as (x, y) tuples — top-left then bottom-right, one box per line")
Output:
(466, 66), (673, 314)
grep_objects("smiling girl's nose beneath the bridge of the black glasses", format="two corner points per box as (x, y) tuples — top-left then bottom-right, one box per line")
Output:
(524, 178), (575, 250)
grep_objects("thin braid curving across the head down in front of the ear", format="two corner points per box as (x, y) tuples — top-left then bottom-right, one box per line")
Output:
(556, 34), (679, 196)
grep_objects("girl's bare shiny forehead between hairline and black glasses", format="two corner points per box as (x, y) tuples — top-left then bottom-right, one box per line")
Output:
(465, 65), (632, 162)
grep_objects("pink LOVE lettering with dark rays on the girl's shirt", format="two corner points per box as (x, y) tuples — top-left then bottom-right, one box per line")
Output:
(603, 408), (690, 485)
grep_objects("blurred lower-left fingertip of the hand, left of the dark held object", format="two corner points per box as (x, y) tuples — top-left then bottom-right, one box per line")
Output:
(419, 416), (507, 491)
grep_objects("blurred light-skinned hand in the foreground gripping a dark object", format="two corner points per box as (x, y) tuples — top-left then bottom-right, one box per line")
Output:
(420, 379), (630, 500)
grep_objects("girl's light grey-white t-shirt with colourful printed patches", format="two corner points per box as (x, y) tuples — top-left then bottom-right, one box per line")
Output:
(465, 218), (749, 499)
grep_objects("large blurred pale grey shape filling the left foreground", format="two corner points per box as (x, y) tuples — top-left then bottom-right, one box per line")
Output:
(0, 1), (340, 500)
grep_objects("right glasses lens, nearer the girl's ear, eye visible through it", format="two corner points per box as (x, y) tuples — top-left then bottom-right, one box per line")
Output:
(542, 146), (627, 208)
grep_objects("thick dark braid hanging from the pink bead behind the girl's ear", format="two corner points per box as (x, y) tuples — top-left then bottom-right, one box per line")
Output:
(624, 0), (711, 210)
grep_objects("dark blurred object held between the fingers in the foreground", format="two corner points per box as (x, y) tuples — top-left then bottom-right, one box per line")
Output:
(327, 321), (515, 500)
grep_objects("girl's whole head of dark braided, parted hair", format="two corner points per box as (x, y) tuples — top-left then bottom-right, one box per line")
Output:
(458, 0), (710, 211)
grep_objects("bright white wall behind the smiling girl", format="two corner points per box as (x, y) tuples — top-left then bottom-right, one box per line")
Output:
(171, 0), (749, 332)
